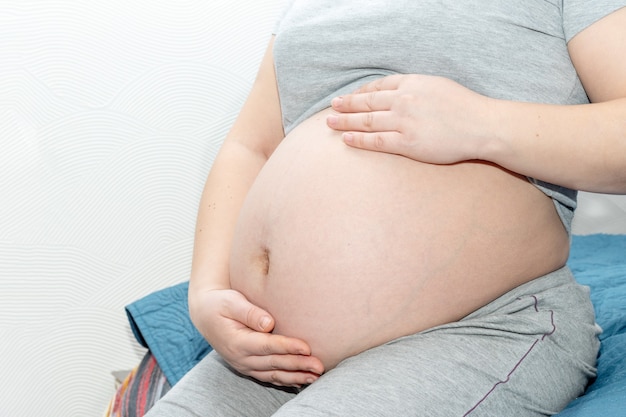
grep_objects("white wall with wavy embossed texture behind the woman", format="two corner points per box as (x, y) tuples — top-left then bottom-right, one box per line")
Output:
(0, 0), (626, 417)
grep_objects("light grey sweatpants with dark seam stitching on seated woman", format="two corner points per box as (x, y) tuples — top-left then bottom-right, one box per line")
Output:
(147, 268), (600, 417)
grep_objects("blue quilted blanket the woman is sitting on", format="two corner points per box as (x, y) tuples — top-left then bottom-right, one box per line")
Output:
(126, 235), (626, 417)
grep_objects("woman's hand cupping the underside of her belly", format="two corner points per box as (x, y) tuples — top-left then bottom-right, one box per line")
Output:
(189, 289), (324, 387)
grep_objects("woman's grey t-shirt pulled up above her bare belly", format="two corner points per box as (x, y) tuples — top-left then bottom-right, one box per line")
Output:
(274, 0), (626, 231)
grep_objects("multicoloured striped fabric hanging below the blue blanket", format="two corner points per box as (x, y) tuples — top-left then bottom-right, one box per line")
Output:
(104, 352), (171, 417)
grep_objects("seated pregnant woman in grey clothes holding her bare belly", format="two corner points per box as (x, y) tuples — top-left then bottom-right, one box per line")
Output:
(149, 0), (626, 416)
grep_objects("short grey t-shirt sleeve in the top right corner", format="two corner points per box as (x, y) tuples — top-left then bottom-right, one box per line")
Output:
(563, 0), (626, 42)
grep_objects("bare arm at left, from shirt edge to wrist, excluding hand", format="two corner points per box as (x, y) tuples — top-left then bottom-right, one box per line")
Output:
(190, 41), (284, 294)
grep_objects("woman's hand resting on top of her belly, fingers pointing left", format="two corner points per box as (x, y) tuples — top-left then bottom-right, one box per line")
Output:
(327, 74), (490, 164)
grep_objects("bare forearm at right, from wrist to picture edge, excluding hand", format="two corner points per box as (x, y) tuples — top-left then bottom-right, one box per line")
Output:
(479, 99), (626, 194)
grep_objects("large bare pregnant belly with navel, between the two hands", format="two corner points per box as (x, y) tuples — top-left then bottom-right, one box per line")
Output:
(230, 108), (568, 369)
